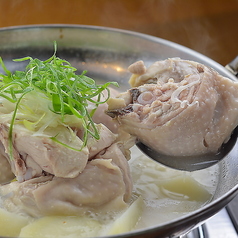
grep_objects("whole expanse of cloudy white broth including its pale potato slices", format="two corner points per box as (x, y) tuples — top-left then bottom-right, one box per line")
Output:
(0, 146), (218, 238)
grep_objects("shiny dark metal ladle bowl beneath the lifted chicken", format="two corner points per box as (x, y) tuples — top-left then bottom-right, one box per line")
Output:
(136, 127), (238, 172)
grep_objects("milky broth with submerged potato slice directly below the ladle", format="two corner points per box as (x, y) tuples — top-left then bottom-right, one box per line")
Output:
(129, 147), (219, 229)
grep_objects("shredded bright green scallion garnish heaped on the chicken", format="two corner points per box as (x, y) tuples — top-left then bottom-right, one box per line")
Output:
(0, 43), (118, 158)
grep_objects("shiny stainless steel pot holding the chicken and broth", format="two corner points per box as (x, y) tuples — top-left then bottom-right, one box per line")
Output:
(0, 25), (238, 238)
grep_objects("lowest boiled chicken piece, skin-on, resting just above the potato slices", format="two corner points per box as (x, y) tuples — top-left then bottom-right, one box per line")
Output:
(0, 142), (132, 217)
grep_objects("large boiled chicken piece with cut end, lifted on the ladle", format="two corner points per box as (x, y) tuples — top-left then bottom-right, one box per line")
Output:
(107, 58), (238, 156)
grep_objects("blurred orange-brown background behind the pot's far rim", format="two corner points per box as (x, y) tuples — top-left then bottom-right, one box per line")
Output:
(0, 0), (238, 65)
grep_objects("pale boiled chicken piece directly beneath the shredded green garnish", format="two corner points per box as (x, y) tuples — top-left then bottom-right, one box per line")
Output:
(0, 124), (89, 181)
